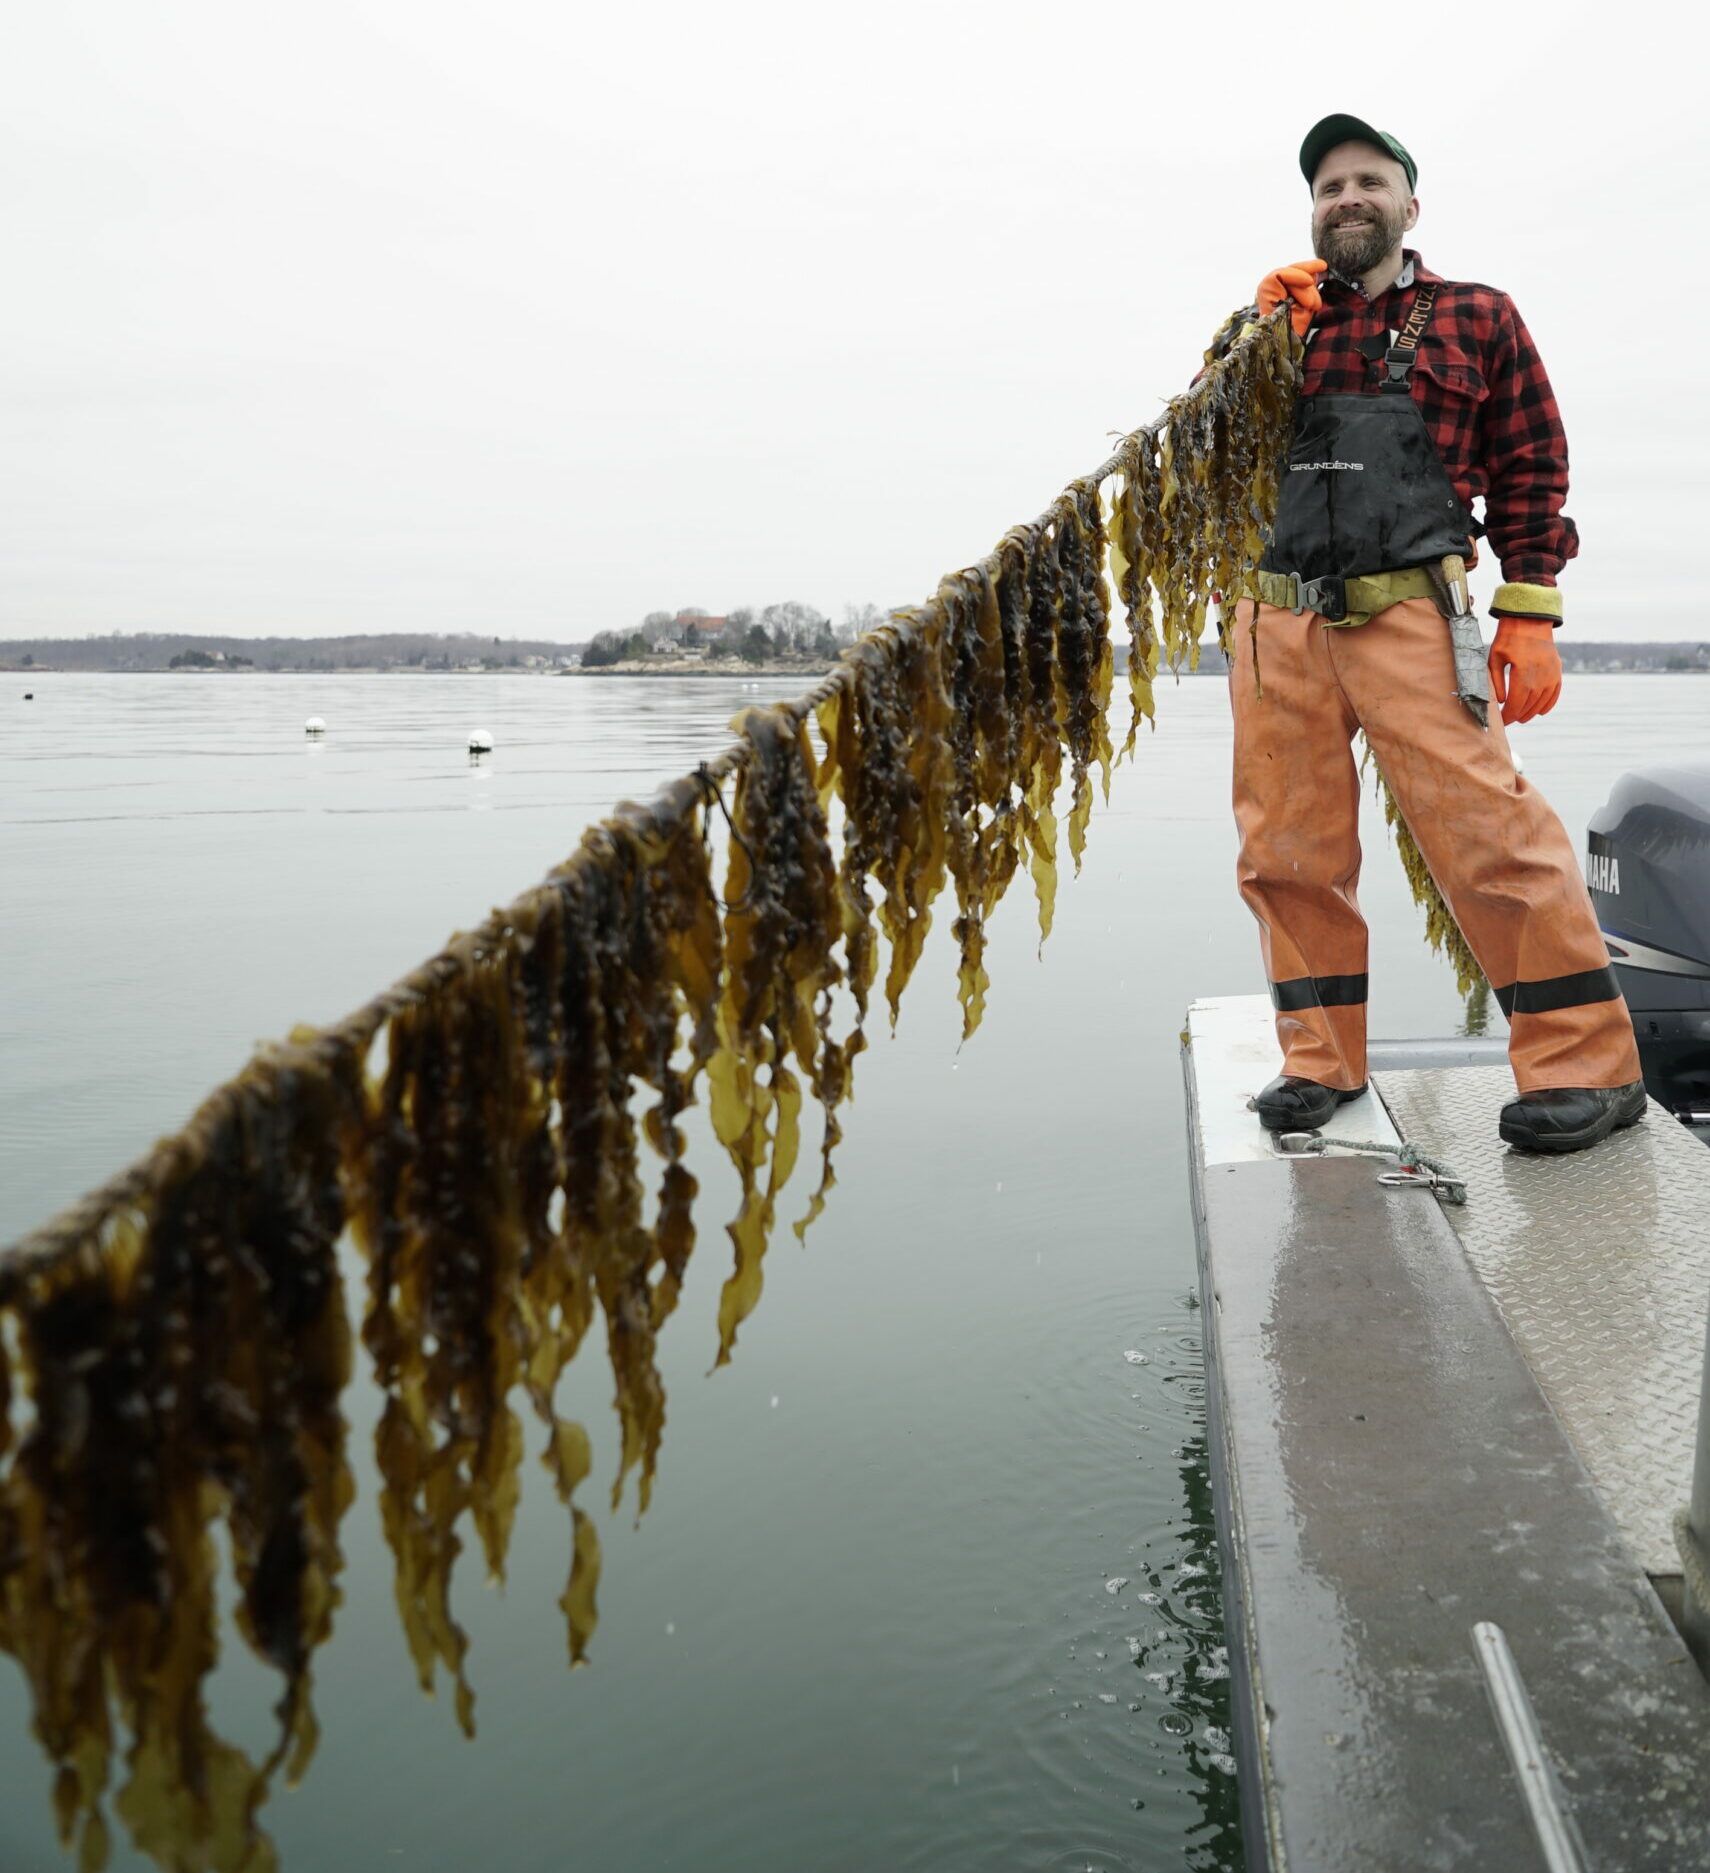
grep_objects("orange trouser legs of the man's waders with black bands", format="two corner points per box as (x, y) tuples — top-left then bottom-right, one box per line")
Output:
(1229, 591), (1639, 1094)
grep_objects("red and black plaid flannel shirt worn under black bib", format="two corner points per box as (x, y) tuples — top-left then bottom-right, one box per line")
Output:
(1214, 247), (1579, 584)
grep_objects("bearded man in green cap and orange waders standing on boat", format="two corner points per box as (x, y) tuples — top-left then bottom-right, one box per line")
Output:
(1225, 114), (1644, 1152)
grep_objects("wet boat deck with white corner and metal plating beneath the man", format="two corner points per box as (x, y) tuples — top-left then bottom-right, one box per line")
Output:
(1186, 996), (1710, 1873)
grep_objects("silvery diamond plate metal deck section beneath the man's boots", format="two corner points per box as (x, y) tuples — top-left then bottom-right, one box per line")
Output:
(1375, 1068), (1710, 1575)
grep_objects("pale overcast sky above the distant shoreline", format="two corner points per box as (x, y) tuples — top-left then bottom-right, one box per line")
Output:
(0, 0), (1710, 639)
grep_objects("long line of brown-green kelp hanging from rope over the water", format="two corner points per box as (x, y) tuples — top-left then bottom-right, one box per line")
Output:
(0, 318), (1452, 1873)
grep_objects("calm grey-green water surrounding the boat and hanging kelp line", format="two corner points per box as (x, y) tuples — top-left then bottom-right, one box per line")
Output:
(0, 676), (1710, 1873)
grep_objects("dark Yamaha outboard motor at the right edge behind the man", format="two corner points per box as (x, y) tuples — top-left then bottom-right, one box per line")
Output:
(1585, 760), (1710, 1126)
